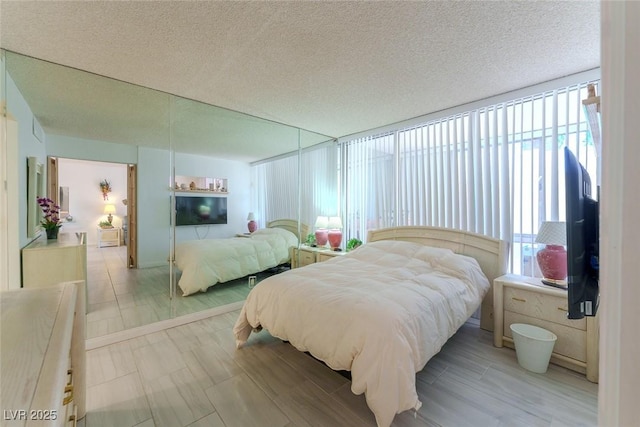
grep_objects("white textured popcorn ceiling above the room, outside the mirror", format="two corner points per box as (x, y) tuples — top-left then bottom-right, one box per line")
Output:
(0, 1), (600, 157)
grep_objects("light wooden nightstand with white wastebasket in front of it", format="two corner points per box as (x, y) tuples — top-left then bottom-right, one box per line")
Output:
(493, 274), (599, 382)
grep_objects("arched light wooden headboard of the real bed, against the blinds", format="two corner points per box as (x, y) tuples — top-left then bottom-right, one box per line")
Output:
(367, 226), (509, 331)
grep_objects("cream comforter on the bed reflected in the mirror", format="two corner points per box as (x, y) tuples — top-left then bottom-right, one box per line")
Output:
(175, 228), (298, 296)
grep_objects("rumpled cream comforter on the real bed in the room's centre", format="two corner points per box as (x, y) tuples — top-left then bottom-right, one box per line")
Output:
(234, 241), (489, 426)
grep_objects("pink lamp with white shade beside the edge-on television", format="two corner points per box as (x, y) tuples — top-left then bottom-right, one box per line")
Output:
(536, 221), (567, 282)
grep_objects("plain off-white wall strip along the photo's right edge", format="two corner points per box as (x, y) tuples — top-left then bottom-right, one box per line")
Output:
(598, 2), (640, 426)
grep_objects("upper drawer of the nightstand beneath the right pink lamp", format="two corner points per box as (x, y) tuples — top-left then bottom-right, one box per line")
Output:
(504, 286), (587, 331)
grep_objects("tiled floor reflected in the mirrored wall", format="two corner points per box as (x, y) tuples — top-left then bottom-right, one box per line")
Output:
(87, 246), (280, 338)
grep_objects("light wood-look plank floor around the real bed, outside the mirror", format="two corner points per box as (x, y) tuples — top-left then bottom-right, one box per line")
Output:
(83, 310), (597, 427)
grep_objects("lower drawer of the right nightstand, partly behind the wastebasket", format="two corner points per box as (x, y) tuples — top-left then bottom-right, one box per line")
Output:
(504, 311), (587, 362)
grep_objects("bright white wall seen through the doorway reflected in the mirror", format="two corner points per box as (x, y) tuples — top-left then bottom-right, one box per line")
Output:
(58, 158), (127, 245)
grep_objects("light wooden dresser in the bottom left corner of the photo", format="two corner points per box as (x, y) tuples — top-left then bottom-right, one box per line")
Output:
(0, 281), (86, 427)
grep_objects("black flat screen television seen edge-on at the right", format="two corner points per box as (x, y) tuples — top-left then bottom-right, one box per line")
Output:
(564, 147), (600, 319)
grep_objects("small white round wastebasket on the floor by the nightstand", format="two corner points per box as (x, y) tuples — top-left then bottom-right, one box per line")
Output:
(511, 323), (558, 374)
